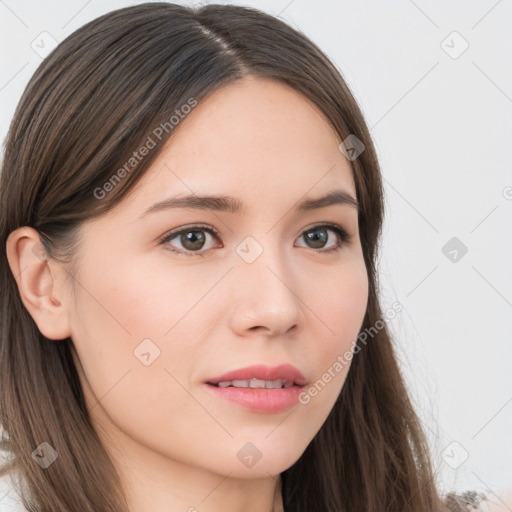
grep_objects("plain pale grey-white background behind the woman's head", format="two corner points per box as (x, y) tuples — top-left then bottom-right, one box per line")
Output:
(0, 0), (512, 504)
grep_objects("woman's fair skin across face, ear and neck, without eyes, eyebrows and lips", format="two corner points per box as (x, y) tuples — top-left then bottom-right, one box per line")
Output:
(7, 78), (368, 512)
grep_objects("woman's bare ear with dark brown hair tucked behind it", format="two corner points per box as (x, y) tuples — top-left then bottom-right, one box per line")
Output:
(6, 226), (71, 340)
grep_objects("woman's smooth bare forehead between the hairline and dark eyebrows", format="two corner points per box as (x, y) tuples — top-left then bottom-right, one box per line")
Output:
(115, 77), (356, 215)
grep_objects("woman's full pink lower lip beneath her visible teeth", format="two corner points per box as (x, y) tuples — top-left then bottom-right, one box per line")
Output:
(205, 384), (304, 414)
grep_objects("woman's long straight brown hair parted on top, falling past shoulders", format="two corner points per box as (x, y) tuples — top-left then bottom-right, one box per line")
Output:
(0, 3), (486, 512)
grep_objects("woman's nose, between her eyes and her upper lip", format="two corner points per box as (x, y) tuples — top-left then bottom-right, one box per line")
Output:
(231, 242), (304, 337)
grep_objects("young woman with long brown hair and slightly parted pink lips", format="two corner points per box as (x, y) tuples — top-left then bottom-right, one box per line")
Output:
(0, 3), (488, 512)
